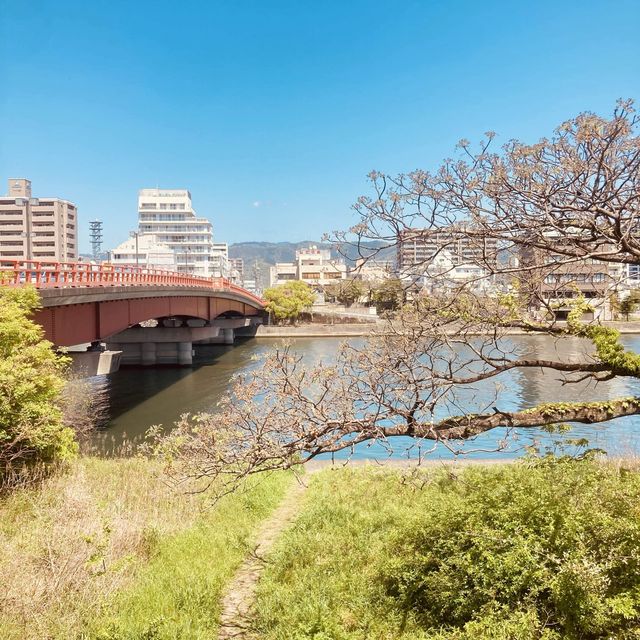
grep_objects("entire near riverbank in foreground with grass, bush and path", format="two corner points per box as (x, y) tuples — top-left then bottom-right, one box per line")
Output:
(0, 458), (640, 640)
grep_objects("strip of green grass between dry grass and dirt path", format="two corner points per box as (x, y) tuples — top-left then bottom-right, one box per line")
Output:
(88, 474), (290, 640)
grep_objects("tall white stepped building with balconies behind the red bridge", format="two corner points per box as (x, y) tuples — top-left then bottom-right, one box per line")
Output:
(138, 189), (214, 276)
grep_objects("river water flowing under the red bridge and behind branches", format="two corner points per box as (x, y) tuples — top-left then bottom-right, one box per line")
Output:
(87, 335), (640, 458)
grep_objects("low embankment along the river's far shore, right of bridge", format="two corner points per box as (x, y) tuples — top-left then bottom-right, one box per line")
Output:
(255, 320), (640, 338)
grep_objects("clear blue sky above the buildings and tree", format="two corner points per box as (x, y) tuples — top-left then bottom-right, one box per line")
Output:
(0, 0), (640, 250)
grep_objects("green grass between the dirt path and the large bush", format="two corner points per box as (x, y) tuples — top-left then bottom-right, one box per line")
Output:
(252, 469), (427, 640)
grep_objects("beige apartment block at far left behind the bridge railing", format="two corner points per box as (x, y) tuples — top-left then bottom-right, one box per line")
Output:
(0, 178), (78, 262)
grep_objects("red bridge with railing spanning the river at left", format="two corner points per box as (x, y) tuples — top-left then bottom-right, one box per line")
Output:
(0, 260), (264, 364)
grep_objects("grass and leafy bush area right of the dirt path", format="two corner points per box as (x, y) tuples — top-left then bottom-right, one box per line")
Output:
(257, 462), (640, 640)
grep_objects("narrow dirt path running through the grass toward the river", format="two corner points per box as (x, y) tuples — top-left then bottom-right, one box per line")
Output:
(218, 480), (307, 640)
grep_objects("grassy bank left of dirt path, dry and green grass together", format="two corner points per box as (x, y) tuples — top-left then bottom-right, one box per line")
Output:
(0, 458), (289, 640)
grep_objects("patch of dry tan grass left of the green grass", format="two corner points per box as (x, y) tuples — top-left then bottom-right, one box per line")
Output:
(0, 458), (199, 640)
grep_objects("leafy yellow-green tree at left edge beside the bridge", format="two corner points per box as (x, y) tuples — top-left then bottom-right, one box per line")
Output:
(0, 287), (77, 476)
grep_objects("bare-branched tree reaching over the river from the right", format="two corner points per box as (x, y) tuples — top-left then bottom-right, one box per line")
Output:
(151, 102), (640, 498)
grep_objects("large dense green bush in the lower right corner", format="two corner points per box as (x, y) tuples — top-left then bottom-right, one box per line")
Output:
(381, 461), (640, 640)
